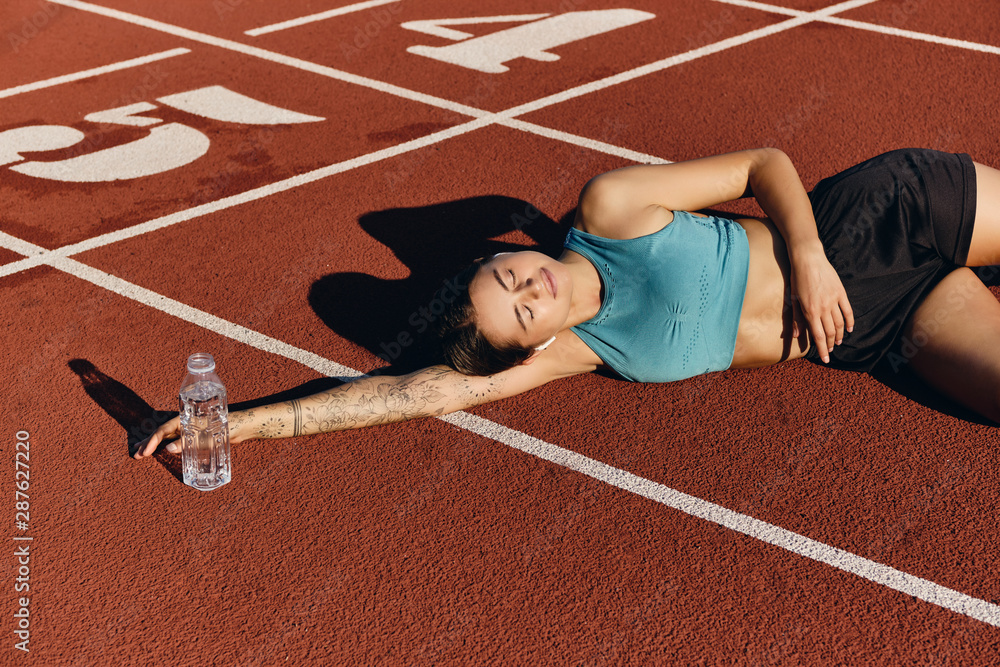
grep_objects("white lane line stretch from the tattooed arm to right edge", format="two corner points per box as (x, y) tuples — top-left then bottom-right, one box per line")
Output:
(448, 412), (1000, 627)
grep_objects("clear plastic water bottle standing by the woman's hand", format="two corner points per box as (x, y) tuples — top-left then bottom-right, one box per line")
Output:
(180, 352), (232, 491)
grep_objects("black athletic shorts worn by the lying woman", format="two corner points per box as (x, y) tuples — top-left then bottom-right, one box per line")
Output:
(807, 149), (976, 371)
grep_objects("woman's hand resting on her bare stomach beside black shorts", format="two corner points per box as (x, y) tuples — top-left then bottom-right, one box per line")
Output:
(789, 241), (854, 363)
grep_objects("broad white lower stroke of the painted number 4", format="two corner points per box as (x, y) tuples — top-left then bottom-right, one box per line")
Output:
(406, 9), (656, 74)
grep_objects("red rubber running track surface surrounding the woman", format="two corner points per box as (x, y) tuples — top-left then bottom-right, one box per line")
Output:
(0, 0), (1000, 665)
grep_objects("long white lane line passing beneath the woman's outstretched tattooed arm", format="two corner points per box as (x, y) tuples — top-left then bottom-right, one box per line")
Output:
(33, 252), (1000, 627)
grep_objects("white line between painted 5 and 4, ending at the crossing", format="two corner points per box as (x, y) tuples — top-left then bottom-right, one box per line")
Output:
(49, 0), (487, 118)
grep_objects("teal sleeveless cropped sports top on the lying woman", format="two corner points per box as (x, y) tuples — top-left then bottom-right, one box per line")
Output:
(564, 211), (750, 382)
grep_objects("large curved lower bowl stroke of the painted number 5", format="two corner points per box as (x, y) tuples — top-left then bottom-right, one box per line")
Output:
(11, 123), (210, 183)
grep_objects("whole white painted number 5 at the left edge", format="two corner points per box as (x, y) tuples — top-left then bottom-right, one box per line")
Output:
(0, 86), (324, 183)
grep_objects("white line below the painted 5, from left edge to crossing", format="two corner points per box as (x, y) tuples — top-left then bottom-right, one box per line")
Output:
(0, 117), (492, 278)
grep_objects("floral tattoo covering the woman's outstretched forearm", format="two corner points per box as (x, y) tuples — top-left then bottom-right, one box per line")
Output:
(230, 366), (503, 438)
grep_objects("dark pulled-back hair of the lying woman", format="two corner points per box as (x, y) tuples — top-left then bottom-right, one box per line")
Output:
(437, 259), (534, 375)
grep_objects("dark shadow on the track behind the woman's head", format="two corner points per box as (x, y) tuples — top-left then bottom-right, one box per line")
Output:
(309, 195), (574, 373)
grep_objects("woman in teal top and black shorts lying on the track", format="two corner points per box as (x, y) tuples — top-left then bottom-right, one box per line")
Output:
(136, 149), (1000, 458)
